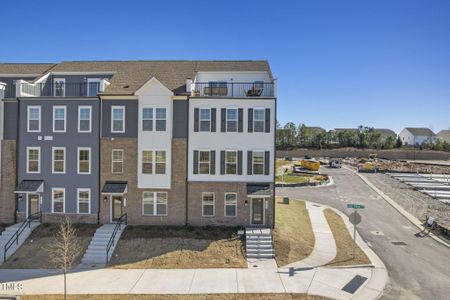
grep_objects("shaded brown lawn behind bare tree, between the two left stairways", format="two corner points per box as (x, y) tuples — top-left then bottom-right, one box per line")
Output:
(0, 223), (99, 269)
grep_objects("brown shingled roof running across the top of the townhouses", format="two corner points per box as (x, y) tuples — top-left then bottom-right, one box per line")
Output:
(0, 60), (272, 95)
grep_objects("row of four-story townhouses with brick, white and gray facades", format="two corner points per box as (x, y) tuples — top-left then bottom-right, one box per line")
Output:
(0, 61), (276, 226)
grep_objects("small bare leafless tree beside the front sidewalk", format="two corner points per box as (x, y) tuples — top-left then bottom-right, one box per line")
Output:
(47, 217), (81, 299)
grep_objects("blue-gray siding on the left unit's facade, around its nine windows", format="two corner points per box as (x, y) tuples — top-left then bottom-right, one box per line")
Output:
(17, 99), (99, 214)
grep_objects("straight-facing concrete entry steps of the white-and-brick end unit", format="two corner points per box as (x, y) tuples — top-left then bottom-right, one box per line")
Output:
(245, 227), (275, 259)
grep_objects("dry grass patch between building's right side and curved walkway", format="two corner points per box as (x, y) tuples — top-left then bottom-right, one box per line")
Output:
(274, 197), (315, 267)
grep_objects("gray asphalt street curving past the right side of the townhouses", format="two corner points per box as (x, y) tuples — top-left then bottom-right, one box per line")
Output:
(276, 169), (450, 300)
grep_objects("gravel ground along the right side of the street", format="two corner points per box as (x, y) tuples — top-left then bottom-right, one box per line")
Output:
(364, 173), (450, 226)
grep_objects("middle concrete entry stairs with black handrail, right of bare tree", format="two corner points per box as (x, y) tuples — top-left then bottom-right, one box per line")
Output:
(80, 224), (126, 267)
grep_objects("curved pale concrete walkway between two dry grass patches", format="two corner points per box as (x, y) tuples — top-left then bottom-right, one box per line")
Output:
(286, 201), (336, 268)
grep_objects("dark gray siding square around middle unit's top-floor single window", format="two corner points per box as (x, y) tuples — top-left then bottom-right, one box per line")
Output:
(102, 100), (139, 138)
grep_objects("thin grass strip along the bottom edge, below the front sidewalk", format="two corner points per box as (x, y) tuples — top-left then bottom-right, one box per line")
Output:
(20, 293), (329, 300)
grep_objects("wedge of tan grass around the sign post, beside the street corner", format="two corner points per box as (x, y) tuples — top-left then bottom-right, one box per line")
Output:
(323, 208), (370, 266)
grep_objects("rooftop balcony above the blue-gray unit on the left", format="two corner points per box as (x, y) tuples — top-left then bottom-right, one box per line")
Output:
(15, 80), (109, 97)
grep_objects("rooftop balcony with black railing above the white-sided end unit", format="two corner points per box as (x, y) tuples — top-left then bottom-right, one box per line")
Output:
(191, 81), (276, 98)
